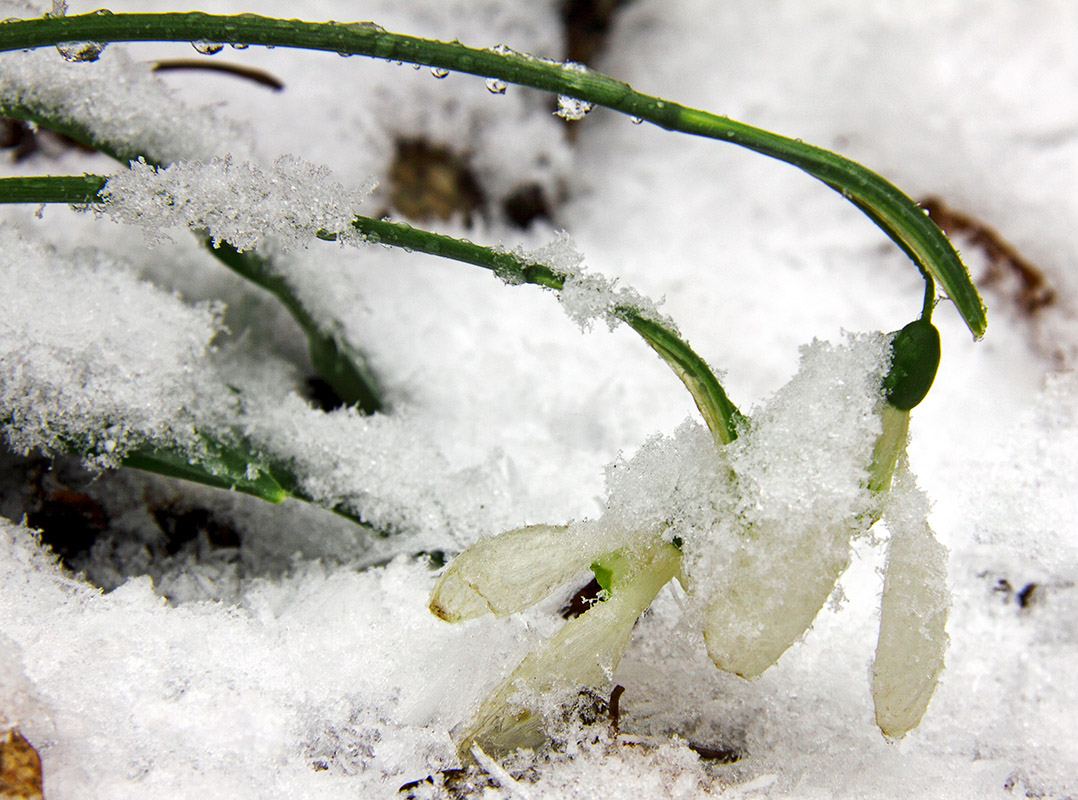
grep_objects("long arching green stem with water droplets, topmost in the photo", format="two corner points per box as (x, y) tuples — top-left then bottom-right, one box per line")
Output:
(0, 12), (986, 337)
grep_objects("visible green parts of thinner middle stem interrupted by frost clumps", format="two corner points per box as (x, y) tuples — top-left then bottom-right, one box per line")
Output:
(0, 175), (744, 443)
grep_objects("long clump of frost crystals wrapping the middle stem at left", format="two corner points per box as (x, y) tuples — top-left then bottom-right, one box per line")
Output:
(100, 155), (374, 251)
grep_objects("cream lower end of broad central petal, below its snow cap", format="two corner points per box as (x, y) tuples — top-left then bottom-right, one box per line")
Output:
(704, 524), (852, 678)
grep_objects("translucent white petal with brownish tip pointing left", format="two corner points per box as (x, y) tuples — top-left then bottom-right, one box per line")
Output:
(430, 523), (625, 622)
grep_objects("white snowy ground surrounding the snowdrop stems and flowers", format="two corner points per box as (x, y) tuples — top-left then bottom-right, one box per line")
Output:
(0, 0), (1078, 800)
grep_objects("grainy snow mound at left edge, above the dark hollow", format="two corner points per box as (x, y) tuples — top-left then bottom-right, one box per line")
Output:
(0, 225), (227, 466)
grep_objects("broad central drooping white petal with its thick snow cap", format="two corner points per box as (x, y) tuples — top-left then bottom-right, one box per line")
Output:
(686, 334), (888, 678)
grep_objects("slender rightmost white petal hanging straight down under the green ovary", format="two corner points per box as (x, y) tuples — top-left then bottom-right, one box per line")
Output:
(872, 465), (950, 739)
